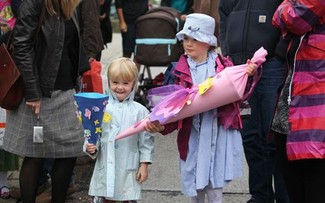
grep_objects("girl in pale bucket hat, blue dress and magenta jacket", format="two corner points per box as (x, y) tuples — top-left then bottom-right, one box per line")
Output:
(147, 13), (255, 203)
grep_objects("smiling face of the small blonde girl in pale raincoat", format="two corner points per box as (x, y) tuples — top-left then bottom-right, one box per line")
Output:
(109, 78), (134, 102)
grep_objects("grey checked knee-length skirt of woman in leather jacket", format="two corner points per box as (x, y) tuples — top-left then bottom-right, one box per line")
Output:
(3, 90), (84, 158)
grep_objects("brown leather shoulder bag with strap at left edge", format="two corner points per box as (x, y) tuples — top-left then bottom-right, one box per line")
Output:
(0, 1), (45, 110)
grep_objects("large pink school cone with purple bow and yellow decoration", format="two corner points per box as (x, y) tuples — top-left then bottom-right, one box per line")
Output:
(115, 47), (267, 140)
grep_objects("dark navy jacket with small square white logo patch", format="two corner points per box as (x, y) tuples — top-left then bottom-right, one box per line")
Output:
(219, 0), (287, 64)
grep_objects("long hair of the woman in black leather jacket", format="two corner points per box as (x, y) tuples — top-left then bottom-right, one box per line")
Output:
(45, 0), (80, 20)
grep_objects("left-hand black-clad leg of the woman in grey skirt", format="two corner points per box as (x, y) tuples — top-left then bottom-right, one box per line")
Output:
(19, 157), (44, 203)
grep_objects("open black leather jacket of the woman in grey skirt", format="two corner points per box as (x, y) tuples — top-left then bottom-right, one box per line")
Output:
(13, 0), (89, 101)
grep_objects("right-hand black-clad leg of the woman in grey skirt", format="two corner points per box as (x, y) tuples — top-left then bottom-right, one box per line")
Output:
(50, 157), (77, 203)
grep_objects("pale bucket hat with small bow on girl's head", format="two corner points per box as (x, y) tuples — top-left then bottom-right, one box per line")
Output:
(176, 13), (217, 46)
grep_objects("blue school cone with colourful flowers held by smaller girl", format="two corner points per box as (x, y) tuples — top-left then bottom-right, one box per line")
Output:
(74, 92), (108, 145)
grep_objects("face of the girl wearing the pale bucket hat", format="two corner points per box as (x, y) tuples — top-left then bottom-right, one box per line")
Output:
(183, 35), (210, 62)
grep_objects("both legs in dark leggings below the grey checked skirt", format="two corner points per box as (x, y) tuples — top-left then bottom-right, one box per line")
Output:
(19, 157), (76, 203)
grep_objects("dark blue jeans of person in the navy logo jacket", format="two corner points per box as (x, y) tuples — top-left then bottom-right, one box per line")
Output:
(241, 58), (289, 203)
